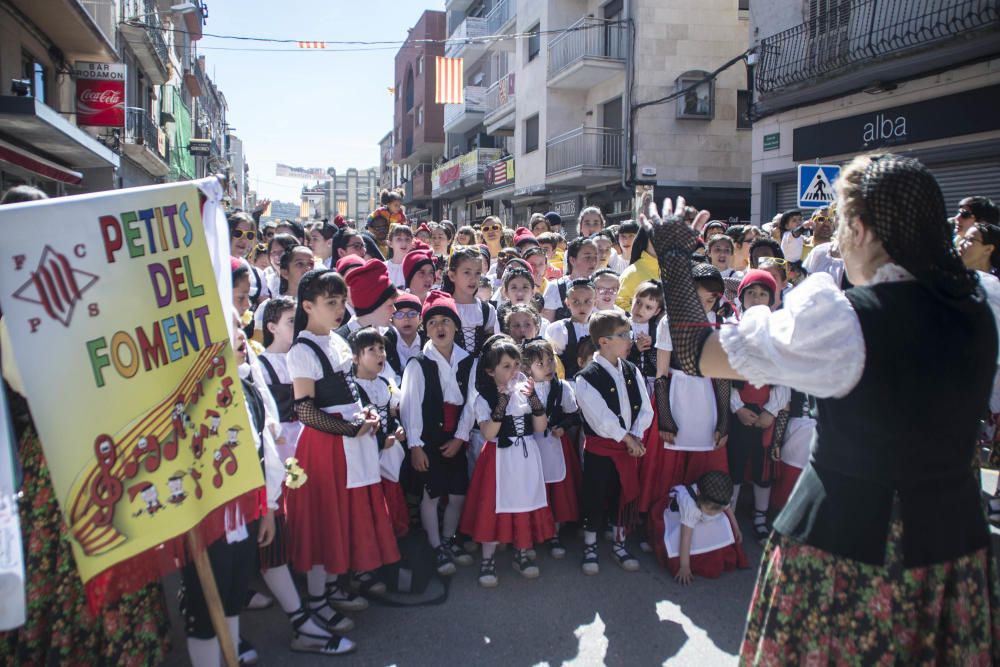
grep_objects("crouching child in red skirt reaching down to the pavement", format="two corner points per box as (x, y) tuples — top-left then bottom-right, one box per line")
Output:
(650, 470), (747, 584)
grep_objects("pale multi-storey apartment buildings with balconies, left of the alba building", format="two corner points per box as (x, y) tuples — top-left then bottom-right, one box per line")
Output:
(432, 0), (750, 235)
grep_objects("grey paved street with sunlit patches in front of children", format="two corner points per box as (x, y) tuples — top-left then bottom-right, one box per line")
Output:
(160, 520), (761, 667)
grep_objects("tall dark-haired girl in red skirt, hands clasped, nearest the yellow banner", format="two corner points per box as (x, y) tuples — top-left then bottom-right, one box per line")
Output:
(286, 269), (399, 640)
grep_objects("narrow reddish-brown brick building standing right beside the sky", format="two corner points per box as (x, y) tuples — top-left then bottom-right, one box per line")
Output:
(393, 10), (446, 219)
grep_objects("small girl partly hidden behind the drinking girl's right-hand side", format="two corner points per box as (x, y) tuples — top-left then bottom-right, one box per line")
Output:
(521, 340), (583, 558)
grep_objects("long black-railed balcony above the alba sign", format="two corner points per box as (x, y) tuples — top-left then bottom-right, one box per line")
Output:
(754, 0), (1000, 108)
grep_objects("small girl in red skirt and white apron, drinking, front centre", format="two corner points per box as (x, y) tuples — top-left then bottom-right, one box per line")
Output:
(461, 334), (555, 588)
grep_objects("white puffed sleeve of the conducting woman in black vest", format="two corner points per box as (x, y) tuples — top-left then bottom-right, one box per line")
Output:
(720, 273), (865, 398)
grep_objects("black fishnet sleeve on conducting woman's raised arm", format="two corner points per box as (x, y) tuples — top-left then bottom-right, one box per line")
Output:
(653, 216), (712, 377)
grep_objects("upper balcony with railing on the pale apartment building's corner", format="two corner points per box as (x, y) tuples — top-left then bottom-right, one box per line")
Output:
(548, 17), (628, 90)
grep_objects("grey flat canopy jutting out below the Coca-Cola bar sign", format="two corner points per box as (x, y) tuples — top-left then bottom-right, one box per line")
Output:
(0, 95), (120, 170)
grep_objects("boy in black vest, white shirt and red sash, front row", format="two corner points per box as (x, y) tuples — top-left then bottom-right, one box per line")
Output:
(576, 311), (653, 574)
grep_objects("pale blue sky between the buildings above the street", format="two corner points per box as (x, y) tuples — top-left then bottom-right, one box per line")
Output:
(196, 0), (436, 203)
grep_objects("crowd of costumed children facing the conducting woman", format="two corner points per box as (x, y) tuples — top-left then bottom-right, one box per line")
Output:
(209, 201), (809, 664)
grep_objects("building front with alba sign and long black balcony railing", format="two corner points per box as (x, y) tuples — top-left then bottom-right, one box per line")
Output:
(750, 0), (1000, 223)
